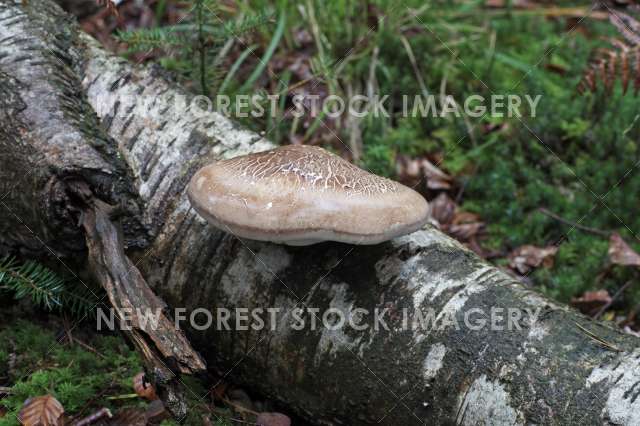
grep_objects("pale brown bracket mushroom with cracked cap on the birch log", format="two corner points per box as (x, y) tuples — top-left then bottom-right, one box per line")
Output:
(188, 145), (428, 246)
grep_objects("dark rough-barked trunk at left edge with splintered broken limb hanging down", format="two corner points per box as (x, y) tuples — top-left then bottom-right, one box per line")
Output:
(0, 1), (205, 417)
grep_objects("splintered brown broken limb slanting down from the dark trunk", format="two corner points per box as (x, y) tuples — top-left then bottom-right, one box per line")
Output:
(78, 182), (206, 418)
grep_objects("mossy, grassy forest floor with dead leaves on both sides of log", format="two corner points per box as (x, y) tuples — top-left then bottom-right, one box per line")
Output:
(0, 0), (640, 425)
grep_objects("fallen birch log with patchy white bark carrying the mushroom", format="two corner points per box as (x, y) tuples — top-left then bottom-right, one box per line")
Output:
(0, 0), (640, 425)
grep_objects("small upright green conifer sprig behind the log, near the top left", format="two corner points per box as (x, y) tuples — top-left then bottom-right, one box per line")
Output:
(116, 0), (270, 96)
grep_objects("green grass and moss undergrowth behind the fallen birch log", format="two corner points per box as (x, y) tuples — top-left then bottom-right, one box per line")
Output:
(109, 0), (640, 305)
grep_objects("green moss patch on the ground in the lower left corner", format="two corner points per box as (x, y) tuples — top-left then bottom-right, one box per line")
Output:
(0, 320), (142, 426)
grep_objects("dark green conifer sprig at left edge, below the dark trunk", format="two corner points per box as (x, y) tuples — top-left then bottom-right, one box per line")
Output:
(0, 257), (99, 315)
